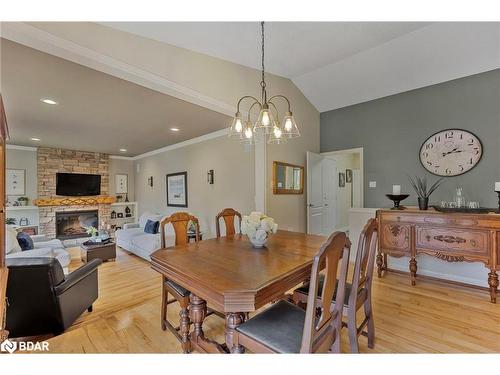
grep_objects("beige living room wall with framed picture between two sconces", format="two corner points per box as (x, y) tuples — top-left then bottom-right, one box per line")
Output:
(135, 137), (255, 238)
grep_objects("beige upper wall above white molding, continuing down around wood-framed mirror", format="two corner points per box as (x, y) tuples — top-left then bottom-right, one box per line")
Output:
(24, 22), (319, 231)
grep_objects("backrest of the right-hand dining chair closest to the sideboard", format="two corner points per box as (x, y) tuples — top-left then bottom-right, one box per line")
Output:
(350, 219), (378, 299)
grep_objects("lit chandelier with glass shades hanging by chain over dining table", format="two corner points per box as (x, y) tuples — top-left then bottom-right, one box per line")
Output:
(228, 22), (300, 144)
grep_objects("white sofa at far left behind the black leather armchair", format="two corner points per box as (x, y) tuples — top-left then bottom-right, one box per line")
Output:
(5, 225), (71, 274)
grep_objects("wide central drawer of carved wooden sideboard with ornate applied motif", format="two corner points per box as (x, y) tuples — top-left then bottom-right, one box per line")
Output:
(416, 227), (489, 256)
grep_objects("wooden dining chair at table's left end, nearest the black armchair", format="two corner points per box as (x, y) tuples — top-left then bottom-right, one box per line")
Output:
(160, 212), (200, 353)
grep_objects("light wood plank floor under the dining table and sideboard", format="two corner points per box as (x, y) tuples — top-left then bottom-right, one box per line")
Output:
(49, 249), (500, 353)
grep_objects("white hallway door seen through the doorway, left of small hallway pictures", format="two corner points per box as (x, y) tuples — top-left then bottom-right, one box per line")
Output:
(321, 157), (338, 236)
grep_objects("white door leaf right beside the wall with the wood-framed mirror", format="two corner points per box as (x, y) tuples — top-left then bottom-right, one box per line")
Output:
(306, 151), (323, 234)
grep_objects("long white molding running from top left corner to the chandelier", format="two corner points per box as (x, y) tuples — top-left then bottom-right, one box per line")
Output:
(0, 22), (236, 116)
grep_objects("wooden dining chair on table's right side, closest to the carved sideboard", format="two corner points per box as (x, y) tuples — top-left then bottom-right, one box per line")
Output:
(293, 219), (378, 353)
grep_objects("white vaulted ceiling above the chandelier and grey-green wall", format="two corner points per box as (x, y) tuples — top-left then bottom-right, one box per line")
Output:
(102, 22), (500, 112)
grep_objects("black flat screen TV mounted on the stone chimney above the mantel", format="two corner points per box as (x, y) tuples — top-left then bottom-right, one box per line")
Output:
(56, 173), (101, 197)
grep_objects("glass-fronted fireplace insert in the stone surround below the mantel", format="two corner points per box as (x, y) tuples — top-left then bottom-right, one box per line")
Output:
(56, 210), (99, 240)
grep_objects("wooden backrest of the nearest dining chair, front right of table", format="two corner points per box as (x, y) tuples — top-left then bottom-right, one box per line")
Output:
(300, 232), (351, 353)
